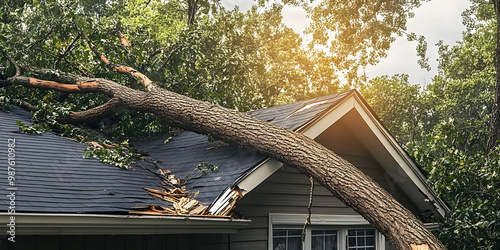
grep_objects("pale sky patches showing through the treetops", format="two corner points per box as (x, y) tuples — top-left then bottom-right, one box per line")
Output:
(222, 0), (470, 86)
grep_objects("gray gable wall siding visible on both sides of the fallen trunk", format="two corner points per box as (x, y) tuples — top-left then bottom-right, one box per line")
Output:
(231, 120), (419, 249)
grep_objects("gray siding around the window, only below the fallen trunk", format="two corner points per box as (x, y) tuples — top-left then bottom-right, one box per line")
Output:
(231, 166), (357, 249)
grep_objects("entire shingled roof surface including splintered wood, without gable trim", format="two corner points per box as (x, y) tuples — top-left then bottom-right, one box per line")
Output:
(0, 92), (348, 217)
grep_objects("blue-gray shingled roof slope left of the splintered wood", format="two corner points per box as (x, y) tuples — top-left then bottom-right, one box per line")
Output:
(0, 107), (165, 214)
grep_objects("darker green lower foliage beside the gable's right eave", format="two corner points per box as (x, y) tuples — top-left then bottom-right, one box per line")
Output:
(413, 124), (500, 249)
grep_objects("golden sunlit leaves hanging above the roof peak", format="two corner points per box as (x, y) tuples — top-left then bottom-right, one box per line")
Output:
(308, 0), (422, 83)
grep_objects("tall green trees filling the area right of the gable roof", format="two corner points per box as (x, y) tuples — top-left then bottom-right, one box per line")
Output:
(362, 1), (500, 249)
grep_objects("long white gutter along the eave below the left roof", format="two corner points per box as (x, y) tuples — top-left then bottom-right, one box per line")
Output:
(0, 212), (251, 235)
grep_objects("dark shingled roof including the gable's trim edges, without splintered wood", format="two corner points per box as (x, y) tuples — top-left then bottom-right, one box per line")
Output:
(0, 90), (446, 219)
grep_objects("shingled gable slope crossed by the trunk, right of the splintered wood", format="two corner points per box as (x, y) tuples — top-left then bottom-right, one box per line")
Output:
(133, 91), (351, 204)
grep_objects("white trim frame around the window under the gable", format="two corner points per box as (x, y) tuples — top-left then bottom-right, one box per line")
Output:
(267, 213), (385, 250)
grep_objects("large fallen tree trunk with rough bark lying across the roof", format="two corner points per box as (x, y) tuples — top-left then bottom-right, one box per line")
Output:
(5, 70), (445, 249)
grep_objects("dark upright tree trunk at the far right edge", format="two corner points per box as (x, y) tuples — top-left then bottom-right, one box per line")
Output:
(486, 0), (500, 151)
